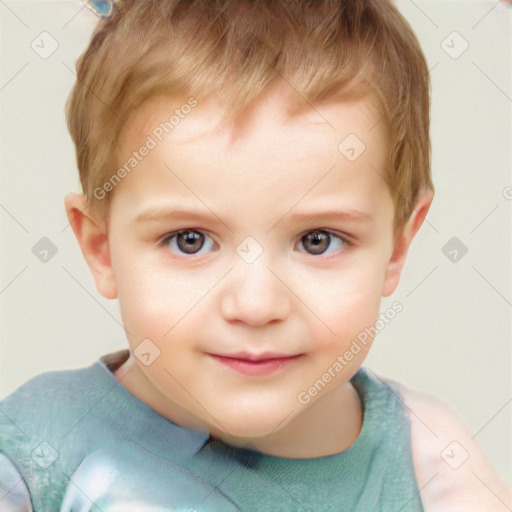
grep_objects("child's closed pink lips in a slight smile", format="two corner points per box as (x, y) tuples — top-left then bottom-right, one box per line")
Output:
(211, 352), (302, 376)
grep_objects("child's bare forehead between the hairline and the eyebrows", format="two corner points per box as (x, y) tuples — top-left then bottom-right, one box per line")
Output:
(114, 86), (390, 226)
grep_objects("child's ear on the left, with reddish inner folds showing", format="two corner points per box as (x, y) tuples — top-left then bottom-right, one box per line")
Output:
(64, 194), (117, 299)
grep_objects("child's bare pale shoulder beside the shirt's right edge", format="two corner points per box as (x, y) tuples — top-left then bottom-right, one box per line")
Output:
(389, 381), (512, 512)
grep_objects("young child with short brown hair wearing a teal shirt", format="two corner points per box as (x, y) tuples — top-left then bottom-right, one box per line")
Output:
(0, 0), (512, 512)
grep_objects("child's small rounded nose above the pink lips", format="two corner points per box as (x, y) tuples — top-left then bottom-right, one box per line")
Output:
(221, 257), (292, 327)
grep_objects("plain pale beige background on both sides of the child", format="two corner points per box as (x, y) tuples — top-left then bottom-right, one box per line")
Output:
(0, 0), (512, 485)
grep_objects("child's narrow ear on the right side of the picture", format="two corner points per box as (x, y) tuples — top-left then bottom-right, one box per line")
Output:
(382, 191), (434, 297)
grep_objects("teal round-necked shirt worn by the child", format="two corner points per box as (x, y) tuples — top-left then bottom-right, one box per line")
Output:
(0, 350), (423, 512)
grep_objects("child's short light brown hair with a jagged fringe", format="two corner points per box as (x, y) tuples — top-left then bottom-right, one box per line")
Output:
(66, 0), (433, 230)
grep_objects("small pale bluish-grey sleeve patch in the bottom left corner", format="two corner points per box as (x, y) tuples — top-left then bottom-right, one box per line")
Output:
(0, 453), (32, 512)
